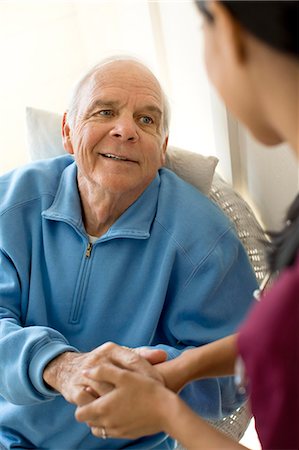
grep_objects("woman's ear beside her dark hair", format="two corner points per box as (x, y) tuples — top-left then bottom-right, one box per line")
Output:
(208, 1), (246, 64)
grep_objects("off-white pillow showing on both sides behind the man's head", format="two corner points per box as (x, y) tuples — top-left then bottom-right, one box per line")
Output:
(26, 107), (218, 194)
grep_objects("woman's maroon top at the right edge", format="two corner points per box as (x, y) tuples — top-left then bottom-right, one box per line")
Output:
(238, 253), (299, 448)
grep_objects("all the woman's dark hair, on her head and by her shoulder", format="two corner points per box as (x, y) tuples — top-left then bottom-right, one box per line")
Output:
(196, 0), (299, 273)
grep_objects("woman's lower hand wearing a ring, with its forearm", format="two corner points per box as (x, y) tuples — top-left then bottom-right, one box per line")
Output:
(75, 365), (245, 450)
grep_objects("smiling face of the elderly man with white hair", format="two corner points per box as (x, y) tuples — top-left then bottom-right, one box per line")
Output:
(66, 61), (167, 196)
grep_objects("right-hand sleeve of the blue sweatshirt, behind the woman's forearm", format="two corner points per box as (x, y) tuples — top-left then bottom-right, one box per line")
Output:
(148, 229), (257, 419)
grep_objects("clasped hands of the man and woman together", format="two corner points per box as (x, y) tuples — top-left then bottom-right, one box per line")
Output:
(44, 342), (180, 438)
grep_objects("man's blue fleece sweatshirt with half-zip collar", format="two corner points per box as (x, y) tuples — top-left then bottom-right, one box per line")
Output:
(0, 156), (256, 450)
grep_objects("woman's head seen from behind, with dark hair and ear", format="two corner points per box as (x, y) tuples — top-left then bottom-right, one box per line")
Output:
(196, 0), (299, 146)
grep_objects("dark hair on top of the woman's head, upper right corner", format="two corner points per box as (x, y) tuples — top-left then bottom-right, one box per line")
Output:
(196, 0), (299, 57)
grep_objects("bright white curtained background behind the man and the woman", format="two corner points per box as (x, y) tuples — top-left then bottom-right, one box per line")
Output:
(0, 0), (298, 228)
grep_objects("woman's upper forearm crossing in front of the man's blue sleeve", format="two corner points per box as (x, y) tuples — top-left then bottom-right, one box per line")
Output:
(157, 334), (237, 392)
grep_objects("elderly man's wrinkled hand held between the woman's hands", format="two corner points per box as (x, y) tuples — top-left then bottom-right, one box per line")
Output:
(43, 342), (166, 406)
